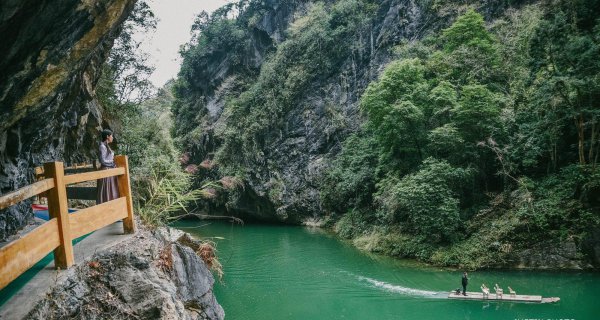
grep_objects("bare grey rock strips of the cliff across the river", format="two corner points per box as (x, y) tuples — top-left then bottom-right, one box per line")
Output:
(178, 0), (520, 223)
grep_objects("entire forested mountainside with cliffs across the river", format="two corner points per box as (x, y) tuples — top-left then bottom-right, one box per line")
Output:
(103, 0), (600, 268)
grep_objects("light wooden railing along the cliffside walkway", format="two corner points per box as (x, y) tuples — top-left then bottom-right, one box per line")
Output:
(0, 156), (135, 289)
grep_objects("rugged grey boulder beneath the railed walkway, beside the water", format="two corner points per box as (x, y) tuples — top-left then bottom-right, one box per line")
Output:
(26, 229), (225, 319)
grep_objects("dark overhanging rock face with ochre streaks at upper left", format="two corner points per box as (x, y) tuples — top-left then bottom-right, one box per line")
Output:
(0, 0), (136, 240)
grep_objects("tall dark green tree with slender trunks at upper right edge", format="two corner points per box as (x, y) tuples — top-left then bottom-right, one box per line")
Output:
(531, 11), (600, 166)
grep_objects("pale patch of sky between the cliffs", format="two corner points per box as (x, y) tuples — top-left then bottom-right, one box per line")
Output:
(136, 0), (230, 88)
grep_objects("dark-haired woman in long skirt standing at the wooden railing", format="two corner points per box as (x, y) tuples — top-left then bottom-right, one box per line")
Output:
(96, 129), (119, 204)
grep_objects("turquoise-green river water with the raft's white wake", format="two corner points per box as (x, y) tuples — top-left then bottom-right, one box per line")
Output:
(173, 221), (600, 320)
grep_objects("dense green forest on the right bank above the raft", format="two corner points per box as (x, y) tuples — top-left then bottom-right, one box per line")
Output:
(321, 6), (600, 267)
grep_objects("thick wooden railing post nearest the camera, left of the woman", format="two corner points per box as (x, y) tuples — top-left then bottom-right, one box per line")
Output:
(44, 162), (75, 269)
